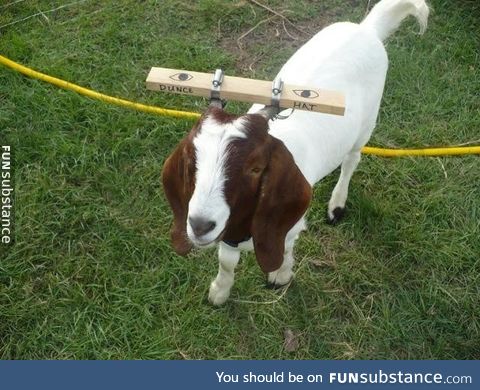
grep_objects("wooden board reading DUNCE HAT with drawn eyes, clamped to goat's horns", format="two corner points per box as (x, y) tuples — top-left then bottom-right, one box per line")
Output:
(147, 67), (345, 115)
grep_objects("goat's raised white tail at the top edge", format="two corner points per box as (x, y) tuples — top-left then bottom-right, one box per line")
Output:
(361, 0), (429, 41)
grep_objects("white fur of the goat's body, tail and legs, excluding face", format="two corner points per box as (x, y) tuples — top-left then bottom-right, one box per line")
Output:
(205, 0), (428, 304)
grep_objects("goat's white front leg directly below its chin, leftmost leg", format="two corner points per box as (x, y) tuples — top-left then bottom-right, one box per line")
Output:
(208, 243), (240, 306)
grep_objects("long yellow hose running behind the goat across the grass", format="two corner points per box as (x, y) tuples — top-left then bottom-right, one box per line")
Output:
(0, 55), (480, 157)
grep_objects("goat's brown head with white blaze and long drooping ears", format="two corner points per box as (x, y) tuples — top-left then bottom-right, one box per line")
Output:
(162, 106), (311, 272)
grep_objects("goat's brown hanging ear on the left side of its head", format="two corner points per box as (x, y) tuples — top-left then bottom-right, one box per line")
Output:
(162, 138), (195, 256)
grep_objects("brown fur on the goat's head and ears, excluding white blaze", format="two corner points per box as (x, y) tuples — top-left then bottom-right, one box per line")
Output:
(163, 109), (312, 272)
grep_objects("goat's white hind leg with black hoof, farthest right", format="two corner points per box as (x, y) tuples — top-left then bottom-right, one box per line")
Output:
(327, 151), (360, 224)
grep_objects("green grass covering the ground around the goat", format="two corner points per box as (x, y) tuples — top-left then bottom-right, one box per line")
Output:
(0, 0), (480, 359)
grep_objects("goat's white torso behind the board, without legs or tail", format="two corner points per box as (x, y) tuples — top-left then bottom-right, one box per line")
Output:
(264, 23), (388, 185)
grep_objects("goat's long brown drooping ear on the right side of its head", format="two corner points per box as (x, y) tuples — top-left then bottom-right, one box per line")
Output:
(251, 137), (312, 272)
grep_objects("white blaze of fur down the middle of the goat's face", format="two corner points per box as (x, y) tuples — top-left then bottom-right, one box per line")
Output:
(187, 117), (246, 247)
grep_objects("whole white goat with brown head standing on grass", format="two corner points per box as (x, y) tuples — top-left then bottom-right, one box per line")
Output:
(162, 0), (429, 305)
